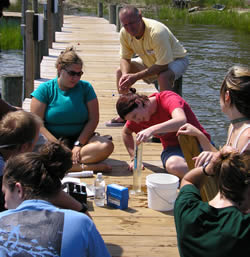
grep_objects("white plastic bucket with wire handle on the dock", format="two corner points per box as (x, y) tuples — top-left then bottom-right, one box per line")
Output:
(146, 173), (179, 211)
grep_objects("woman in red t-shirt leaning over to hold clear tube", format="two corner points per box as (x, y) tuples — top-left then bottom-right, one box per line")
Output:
(116, 88), (210, 178)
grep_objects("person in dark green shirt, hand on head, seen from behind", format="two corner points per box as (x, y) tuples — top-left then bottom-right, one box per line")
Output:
(174, 146), (250, 257)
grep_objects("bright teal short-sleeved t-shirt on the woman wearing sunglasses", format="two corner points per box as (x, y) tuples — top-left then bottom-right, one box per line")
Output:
(31, 78), (96, 138)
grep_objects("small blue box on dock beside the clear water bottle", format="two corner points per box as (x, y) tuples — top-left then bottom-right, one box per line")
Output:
(107, 184), (129, 210)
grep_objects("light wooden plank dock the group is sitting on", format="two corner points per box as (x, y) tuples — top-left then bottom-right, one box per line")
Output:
(23, 15), (179, 257)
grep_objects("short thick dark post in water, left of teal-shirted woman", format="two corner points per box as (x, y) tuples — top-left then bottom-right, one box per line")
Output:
(0, 74), (23, 107)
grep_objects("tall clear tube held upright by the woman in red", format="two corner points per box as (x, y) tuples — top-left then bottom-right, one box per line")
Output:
(130, 141), (142, 194)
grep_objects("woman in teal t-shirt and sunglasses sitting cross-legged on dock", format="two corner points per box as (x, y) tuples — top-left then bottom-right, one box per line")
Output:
(31, 47), (114, 171)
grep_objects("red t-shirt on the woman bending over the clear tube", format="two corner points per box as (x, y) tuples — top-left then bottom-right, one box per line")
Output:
(126, 91), (211, 149)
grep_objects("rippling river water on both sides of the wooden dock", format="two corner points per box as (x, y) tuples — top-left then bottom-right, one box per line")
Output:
(0, 24), (250, 146)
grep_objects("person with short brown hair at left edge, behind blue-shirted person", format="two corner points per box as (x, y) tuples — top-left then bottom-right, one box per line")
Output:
(0, 110), (89, 215)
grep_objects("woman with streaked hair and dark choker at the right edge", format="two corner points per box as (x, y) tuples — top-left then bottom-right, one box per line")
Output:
(177, 66), (250, 167)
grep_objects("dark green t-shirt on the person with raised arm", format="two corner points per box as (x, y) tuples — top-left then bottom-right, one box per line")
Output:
(174, 185), (250, 257)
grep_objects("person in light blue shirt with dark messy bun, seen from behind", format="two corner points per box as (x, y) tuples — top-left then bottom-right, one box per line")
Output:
(0, 142), (110, 257)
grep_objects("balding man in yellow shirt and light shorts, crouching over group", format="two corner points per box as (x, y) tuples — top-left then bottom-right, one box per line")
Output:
(107, 5), (188, 126)
